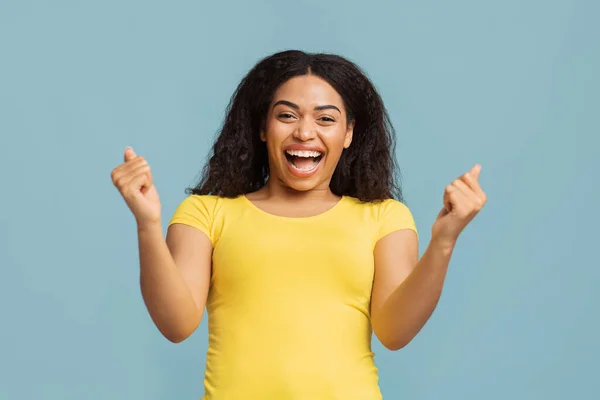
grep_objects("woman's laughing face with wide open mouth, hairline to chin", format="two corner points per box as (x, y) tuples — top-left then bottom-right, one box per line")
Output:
(261, 75), (354, 191)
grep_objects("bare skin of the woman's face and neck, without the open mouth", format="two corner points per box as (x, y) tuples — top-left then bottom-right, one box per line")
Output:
(246, 75), (354, 217)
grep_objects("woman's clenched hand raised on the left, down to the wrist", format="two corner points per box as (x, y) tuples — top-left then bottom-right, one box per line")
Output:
(111, 147), (161, 227)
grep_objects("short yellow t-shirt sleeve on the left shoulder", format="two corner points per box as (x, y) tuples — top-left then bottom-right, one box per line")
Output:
(169, 195), (217, 244)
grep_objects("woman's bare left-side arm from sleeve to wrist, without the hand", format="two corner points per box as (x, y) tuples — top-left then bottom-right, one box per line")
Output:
(138, 220), (212, 343)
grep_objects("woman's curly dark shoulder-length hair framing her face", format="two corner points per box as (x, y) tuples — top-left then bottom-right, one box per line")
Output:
(186, 50), (402, 202)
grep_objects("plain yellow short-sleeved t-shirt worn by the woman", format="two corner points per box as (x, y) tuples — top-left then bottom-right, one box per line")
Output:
(170, 195), (416, 400)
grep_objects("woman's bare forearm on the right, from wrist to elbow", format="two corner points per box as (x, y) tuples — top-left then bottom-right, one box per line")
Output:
(374, 240), (454, 350)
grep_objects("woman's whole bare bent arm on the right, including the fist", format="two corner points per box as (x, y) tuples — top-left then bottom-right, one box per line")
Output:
(371, 165), (487, 350)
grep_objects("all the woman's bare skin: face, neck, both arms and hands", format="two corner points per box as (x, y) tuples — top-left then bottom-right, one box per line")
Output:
(111, 75), (486, 350)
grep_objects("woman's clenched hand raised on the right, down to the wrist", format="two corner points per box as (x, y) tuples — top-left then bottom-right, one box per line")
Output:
(431, 164), (487, 247)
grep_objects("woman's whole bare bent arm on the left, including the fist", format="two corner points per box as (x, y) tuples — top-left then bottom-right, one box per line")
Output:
(111, 147), (212, 342)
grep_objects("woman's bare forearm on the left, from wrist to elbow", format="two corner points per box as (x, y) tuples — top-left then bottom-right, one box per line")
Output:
(138, 224), (202, 342)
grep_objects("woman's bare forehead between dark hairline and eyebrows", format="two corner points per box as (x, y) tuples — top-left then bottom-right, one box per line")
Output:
(273, 75), (343, 110)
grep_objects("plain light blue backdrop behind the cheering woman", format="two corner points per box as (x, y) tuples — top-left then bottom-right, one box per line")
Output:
(0, 0), (600, 400)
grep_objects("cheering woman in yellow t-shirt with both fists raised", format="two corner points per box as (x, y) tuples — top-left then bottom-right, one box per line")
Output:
(112, 51), (486, 400)
